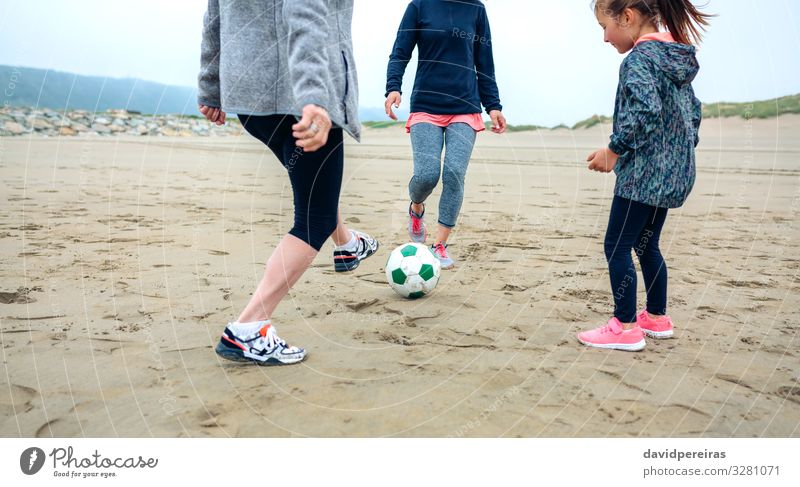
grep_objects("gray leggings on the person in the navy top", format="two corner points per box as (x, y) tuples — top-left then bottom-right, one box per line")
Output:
(408, 123), (475, 228)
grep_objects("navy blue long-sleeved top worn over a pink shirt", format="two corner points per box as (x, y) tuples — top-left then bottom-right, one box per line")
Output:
(386, 0), (503, 115)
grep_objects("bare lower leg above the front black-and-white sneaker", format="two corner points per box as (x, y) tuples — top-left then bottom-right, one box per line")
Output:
(238, 235), (317, 323)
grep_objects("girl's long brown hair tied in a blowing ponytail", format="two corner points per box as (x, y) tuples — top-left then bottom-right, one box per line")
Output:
(592, 0), (714, 44)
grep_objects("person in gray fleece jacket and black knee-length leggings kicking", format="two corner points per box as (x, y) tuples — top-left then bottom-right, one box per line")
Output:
(198, 0), (378, 365)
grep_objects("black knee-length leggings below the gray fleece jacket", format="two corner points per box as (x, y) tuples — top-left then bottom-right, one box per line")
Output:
(234, 115), (344, 251)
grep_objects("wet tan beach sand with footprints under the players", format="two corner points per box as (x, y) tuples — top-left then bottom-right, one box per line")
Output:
(0, 116), (800, 437)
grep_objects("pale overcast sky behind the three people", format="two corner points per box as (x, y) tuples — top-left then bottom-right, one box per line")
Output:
(0, 0), (800, 126)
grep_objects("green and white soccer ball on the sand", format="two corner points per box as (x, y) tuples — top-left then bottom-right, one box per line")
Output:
(386, 243), (442, 299)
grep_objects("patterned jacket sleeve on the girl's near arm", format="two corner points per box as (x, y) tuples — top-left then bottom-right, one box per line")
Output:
(608, 58), (661, 155)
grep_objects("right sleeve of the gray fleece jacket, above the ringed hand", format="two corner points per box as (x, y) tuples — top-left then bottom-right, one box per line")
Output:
(283, 0), (330, 111)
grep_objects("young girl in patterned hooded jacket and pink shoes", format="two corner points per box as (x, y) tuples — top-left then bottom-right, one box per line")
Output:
(578, 0), (710, 351)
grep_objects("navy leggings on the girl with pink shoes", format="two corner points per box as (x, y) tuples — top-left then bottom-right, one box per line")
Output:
(605, 196), (667, 323)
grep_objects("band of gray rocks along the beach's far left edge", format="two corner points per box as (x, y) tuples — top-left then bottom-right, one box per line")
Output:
(0, 107), (243, 137)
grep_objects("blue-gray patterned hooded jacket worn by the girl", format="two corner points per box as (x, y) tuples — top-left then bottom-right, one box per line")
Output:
(609, 36), (701, 208)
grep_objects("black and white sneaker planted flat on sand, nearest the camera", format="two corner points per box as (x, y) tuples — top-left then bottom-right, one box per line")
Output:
(215, 321), (306, 365)
